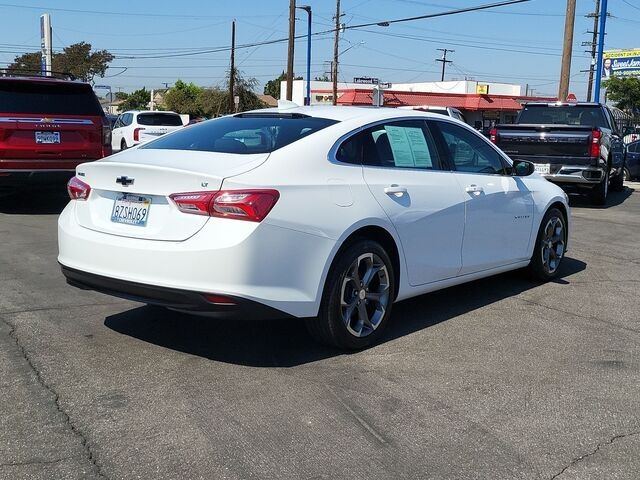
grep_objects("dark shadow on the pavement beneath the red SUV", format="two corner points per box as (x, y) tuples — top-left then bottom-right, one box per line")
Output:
(0, 186), (69, 215)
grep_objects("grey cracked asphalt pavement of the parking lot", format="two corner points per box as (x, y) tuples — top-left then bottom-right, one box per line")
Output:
(0, 183), (640, 480)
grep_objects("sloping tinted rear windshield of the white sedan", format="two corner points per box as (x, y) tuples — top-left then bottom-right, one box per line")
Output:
(141, 114), (337, 154)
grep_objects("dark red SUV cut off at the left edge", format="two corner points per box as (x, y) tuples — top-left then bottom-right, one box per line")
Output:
(0, 77), (111, 190)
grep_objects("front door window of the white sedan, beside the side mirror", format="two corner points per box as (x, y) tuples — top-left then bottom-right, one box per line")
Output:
(429, 121), (508, 175)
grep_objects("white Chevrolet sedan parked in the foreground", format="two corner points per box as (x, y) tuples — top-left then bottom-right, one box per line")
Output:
(58, 106), (570, 349)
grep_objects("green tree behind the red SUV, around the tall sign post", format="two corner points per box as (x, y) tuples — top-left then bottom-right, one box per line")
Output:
(6, 42), (114, 82)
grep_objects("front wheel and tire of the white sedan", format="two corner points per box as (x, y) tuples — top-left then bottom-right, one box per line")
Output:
(529, 208), (568, 282)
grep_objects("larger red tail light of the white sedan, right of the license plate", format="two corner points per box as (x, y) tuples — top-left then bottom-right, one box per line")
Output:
(169, 190), (280, 222)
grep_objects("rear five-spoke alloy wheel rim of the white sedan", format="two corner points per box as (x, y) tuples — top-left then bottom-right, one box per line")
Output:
(340, 253), (391, 337)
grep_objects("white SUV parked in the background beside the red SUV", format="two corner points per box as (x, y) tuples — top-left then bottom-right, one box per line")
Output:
(111, 110), (183, 151)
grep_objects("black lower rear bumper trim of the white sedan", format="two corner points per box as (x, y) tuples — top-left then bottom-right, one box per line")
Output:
(61, 265), (290, 319)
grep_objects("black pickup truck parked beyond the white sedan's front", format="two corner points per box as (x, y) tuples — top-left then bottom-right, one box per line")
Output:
(490, 103), (624, 205)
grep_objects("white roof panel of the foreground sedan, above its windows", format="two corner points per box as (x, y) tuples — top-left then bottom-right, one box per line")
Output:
(243, 105), (450, 122)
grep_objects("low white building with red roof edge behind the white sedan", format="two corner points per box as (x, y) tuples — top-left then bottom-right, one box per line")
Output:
(280, 78), (556, 127)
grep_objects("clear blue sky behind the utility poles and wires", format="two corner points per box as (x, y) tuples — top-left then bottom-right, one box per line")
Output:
(0, 0), (640, 98)
